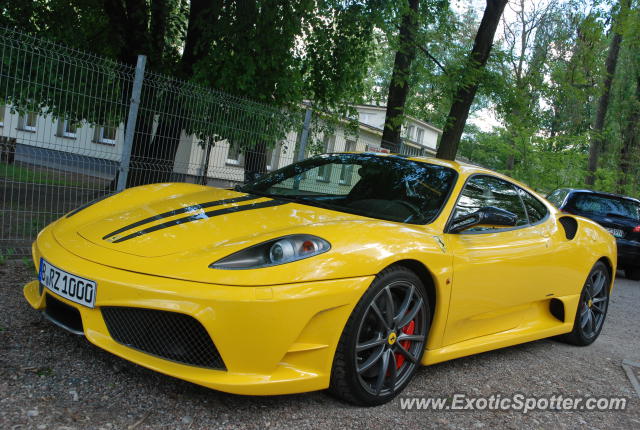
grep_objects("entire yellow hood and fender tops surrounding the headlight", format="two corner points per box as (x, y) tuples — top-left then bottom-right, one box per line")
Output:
(48, 184), (442, 285)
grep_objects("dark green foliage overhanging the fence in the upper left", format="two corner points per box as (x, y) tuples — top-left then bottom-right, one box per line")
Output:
(0, 0), (386, 170)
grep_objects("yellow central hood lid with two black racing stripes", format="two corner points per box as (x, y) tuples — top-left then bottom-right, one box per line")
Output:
(54, 184), (361, 257)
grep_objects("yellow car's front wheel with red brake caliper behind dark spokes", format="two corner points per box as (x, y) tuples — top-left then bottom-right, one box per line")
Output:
(328, 266), (431, 406)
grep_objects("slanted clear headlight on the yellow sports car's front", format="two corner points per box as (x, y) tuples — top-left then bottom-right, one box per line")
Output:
(209, 234), (331, 269)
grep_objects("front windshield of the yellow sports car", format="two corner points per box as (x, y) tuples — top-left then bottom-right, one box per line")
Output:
(239, 154), (457, 224)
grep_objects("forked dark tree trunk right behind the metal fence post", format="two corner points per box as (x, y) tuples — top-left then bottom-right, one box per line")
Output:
(103, 0), (222, 189)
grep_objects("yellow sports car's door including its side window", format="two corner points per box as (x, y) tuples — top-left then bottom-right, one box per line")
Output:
(443, 174), (550, 345)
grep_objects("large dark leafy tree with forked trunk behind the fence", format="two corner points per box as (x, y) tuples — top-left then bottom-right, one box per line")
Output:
(0, 0), (379, 185)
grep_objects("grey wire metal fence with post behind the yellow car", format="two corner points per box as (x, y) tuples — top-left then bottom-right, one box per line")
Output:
(0, 28), (436, 258)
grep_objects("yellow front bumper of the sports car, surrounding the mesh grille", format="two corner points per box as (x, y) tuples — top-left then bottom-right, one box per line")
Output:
(24, 229), (373, 395)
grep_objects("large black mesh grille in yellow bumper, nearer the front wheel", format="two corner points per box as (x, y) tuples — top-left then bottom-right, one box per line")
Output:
(102, 306), (226, 369)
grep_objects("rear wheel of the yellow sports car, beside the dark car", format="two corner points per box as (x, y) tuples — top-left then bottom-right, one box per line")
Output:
(560, 261), (611, 346)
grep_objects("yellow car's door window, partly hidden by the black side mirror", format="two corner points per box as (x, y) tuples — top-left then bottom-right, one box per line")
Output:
(454, 175), (528, 231)
